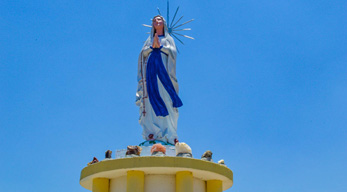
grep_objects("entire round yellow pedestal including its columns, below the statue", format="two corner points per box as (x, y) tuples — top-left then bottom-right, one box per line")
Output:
(80, 156), (233, 192)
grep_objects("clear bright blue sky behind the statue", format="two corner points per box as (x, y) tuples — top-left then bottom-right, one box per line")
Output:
(0, 0), (347, 192)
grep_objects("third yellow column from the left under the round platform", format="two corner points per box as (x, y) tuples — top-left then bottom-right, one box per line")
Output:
(176, 171), (193, 192)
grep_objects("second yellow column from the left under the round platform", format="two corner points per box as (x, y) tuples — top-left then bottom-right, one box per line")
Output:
(127, 171), (145, 192)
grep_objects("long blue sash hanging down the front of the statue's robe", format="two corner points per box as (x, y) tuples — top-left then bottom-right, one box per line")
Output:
(146, 47), (183, 117)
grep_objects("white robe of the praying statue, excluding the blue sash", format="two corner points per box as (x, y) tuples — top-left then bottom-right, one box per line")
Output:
(136, 33), (178, 144)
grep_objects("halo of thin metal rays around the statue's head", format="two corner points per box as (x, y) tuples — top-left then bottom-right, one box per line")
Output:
(142, 0), (194, 45)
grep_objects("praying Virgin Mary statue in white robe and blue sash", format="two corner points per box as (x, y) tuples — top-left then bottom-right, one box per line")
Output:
(136, 15), (183, 144)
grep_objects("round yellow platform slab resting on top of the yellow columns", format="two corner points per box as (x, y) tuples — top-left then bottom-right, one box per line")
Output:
(80, 157), (233, 191)
